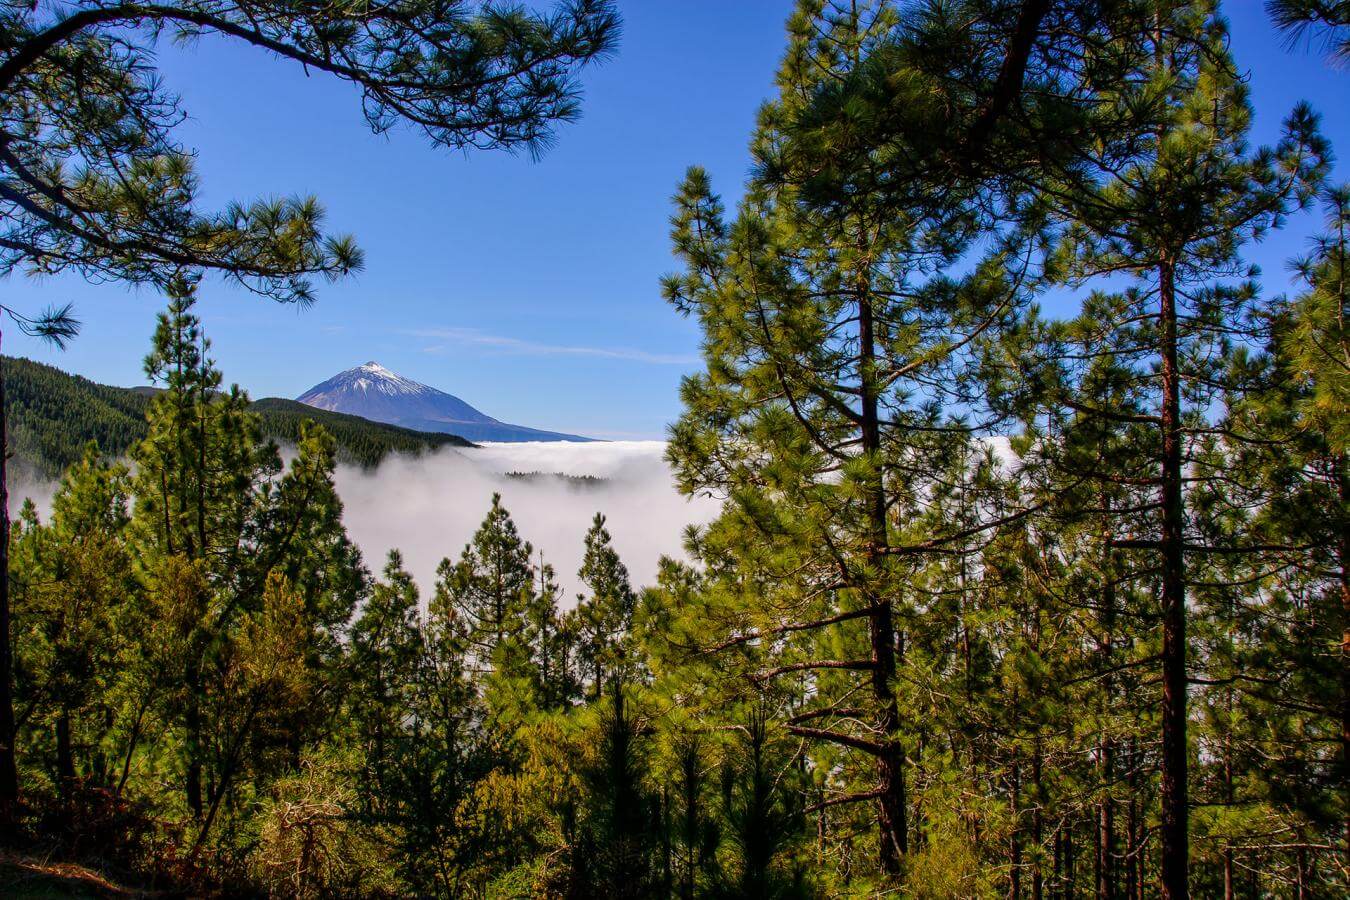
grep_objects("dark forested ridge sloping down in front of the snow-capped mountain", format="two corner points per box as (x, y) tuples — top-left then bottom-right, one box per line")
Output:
(0, 356), (473, 478)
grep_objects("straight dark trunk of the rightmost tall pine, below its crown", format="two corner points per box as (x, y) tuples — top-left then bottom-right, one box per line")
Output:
(1158, 259), (1189, 900)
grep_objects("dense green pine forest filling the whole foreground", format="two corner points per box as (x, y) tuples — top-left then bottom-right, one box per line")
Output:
(0, 0), (1350, 900)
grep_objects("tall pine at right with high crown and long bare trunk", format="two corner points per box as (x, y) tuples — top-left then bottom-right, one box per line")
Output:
(1026, 3), (1324, 899)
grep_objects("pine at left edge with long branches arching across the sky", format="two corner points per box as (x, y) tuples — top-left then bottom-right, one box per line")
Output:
(0, 0), (620, 823)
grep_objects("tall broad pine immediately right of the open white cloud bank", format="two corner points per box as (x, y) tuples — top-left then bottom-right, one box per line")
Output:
(664, 4), (1025, 876)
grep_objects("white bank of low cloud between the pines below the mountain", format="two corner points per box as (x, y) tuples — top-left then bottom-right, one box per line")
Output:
(338, 441), (720, 606)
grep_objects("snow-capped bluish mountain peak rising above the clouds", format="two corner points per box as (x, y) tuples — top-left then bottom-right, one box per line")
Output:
(297, 363), (591, 443)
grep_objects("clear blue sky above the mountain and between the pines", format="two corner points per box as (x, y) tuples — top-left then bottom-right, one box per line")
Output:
(4, 0), (1350, 439)
